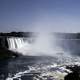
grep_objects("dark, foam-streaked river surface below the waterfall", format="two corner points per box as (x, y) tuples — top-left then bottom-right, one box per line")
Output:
(0, 55), (80, 80)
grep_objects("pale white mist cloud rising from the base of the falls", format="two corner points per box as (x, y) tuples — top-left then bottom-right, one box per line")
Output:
(33, 33), (62, 56)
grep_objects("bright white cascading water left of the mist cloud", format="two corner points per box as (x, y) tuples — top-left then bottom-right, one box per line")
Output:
(7, 37), (30, 55)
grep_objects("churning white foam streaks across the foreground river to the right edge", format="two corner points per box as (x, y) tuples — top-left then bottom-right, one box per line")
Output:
(6, 56), (80, 80)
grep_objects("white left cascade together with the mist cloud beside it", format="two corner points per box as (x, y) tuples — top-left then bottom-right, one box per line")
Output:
(7, 33), (63, 56)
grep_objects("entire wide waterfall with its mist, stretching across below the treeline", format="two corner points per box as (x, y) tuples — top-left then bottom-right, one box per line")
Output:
(0, 32), (80, 56)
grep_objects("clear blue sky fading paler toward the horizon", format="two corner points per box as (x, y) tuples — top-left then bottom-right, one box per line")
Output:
(0, 0), (80, 32)
